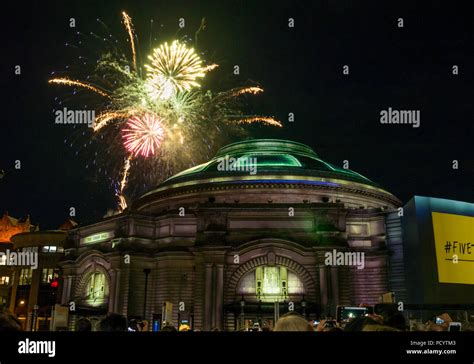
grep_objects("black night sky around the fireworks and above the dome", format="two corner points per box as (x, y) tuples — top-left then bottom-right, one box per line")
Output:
(0, 0), (474, 229)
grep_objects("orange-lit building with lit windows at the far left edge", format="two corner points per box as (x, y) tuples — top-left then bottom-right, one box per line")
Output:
(0, 216), (77, 331)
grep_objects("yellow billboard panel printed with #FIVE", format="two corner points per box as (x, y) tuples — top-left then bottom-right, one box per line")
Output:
(431, 212), (474, 284)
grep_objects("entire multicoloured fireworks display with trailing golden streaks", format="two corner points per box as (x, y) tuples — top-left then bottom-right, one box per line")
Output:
(49, 12), (282, 211)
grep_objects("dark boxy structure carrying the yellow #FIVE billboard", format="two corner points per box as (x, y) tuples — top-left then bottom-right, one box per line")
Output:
(387, 196), (474, 322)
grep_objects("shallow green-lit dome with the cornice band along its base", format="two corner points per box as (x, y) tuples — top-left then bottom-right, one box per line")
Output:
(135, 139), (400, 209)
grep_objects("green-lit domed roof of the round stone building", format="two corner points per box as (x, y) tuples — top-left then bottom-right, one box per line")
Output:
(134, 139), (400, 208)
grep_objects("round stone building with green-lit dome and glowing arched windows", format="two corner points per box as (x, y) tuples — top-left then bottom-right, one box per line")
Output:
(61, 139), (401, 330)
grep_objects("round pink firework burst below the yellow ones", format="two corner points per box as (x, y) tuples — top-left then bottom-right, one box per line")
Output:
(122, 114), (165, 158)
